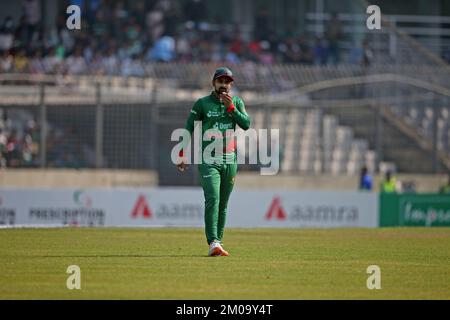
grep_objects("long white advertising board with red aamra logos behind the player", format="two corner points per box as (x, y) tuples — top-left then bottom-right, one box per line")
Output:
(0, 187), (379, 228)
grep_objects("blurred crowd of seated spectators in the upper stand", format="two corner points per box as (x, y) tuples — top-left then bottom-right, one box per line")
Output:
(0, 0), (367, 76)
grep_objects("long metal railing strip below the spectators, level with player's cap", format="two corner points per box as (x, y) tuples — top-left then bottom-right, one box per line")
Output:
(0, 63), (450, 96)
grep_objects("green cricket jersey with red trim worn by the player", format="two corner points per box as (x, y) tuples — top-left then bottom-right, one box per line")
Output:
(185, 91), (250, 162)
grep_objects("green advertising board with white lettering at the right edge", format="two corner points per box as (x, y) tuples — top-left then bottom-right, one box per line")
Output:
(379, 193), (450, 227)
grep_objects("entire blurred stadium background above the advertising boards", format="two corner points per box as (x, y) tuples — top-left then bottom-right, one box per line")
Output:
(0, 0), (450, 192)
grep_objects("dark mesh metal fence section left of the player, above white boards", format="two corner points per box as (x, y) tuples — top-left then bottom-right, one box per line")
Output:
(1, 85), (156, 169)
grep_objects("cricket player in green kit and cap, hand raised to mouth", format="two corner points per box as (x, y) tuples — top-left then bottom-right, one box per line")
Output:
(177, 67), (250, 256)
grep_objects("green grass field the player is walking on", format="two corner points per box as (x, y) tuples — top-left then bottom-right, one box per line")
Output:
(0, 228), (450, 299)
